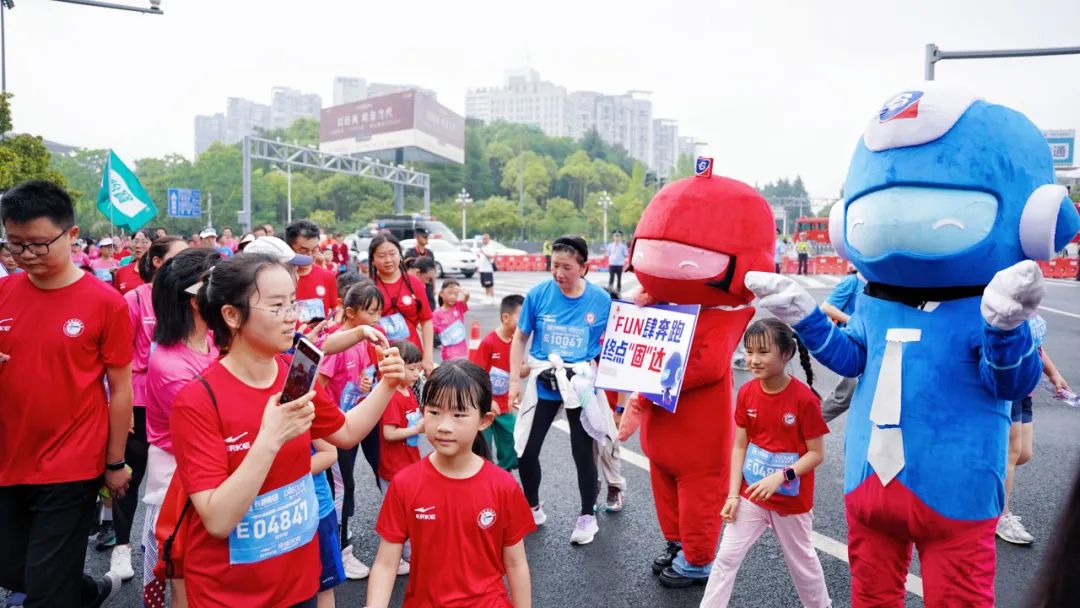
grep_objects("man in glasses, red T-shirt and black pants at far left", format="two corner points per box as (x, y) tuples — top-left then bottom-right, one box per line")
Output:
(0, 181), (133, 606)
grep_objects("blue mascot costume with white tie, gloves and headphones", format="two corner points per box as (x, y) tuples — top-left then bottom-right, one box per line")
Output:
(746, 83), (1080, 607)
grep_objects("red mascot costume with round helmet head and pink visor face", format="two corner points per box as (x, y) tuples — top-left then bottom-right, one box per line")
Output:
(620, 167), (775, 587)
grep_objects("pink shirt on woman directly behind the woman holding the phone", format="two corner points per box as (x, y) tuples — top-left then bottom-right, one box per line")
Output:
(146, 336), (218, 454)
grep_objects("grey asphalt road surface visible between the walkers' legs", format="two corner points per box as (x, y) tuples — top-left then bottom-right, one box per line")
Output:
(12, 272), (1080, 608)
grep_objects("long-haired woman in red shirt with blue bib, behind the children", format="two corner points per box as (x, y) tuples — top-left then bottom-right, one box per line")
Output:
(367, 234), (435, 375)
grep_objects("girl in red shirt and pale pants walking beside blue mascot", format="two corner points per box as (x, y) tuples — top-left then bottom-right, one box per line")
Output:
(704, 319), (832, 608)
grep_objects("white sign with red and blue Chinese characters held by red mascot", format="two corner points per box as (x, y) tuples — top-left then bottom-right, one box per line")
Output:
(596, 300), (701, 413)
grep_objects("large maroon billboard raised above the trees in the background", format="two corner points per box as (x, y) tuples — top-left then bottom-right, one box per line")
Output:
(319, 91), (465, 163)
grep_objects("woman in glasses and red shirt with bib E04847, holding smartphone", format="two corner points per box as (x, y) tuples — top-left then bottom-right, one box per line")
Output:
(172, 254), (405, 608)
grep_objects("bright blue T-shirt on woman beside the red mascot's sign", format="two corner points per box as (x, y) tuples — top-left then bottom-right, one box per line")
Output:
(517, 279), (611, 401)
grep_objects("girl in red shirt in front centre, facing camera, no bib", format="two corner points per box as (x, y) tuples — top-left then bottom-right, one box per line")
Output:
(367, 359), (536, 608)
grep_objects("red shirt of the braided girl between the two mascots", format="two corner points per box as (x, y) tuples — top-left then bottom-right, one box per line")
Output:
(735, 378), (828, 515)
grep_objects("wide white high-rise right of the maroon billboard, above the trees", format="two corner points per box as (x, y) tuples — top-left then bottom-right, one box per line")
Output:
(465, 68), (570, 137)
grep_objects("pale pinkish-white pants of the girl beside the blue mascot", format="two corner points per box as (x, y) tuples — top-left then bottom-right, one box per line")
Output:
(701, 498), (832, 608)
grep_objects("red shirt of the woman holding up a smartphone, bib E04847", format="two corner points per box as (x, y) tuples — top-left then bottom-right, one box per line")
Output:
(172, 360), (345, 606)
